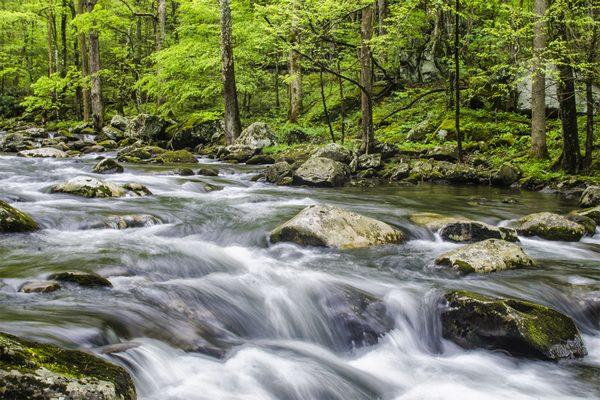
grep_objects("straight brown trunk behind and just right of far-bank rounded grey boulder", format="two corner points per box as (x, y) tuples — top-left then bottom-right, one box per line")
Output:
(360, 4), (374, 154)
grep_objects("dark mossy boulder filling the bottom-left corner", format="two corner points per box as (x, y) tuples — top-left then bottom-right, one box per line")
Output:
(0, 333), (136, 400)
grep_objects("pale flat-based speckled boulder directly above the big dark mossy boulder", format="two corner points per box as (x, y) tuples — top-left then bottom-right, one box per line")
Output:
(435, 239), (535, 274)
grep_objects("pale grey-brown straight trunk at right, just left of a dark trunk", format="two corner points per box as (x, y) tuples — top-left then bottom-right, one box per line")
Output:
(531, 0), (548, 158)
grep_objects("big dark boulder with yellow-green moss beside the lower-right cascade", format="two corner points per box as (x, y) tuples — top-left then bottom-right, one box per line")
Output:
(441, 291), (587, 360)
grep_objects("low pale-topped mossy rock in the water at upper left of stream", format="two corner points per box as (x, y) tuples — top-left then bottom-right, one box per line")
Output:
(51, 176), (152, 197)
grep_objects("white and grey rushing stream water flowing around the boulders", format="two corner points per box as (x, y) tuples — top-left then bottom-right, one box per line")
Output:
(0, 155), (600, 400)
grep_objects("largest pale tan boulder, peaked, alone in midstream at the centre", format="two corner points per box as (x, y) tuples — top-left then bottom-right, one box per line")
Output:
(271, 205), (404, 249)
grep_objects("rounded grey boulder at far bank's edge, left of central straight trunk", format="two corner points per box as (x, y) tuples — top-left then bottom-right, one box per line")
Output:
(293, 157), (350, 187)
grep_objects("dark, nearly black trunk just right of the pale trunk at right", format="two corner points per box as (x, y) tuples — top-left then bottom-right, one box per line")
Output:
(558, 64), (581, 174)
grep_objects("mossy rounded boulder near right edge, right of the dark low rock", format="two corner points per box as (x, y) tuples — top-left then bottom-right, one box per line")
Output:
(515, 212), (585, 242)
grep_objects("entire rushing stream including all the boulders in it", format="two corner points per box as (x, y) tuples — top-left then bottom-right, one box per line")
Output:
(0, 121), (600, 399)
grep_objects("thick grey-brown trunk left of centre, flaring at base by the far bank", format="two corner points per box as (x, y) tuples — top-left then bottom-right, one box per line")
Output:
(219, 0), (242, 144)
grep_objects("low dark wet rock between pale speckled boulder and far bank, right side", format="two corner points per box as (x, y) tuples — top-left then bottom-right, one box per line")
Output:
(438, 221), (518, 243)
